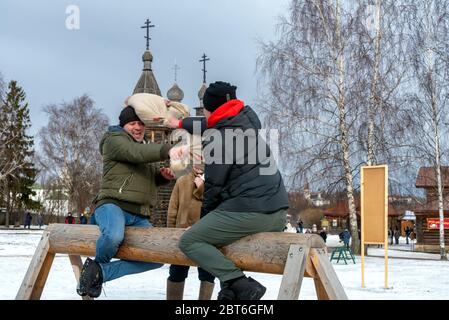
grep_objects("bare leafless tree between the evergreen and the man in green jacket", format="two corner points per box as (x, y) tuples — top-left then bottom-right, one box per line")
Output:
(39, 95), (108, 212)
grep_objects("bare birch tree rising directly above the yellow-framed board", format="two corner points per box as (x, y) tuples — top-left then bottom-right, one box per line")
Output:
(354, 0), (408, 170)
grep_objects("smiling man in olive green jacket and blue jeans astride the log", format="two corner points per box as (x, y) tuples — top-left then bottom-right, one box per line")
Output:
(77, 106), (180, 298)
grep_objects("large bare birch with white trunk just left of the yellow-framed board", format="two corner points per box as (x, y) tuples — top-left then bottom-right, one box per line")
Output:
(258, 0), (360, 253)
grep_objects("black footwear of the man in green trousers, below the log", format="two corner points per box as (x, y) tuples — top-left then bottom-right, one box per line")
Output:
(217, 277), (267, 300)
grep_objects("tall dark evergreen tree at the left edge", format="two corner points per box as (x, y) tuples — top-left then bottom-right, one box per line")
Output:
(0, 80), (38, 227)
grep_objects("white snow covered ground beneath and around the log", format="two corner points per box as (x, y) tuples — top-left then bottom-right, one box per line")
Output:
(0, 230), (449, 300)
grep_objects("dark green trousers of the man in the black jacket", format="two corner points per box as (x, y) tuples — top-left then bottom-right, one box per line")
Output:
(179, 210), (287, 282)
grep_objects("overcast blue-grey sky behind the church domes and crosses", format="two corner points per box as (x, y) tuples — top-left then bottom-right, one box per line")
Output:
(0, 0), (288, 138)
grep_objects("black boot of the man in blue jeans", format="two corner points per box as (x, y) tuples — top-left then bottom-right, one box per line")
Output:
(76, 258), (103, 298)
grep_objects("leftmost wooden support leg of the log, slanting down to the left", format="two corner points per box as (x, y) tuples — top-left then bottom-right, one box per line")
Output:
(16, 231), (55, 300)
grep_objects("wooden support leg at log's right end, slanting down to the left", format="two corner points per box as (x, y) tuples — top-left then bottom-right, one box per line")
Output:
(278, 244), (309, 300)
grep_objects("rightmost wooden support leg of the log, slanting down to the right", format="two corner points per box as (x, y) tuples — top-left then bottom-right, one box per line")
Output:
(310, 249), (348, 300)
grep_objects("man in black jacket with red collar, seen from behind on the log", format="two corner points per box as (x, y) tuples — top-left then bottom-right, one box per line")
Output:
(166, 82), (288, 300)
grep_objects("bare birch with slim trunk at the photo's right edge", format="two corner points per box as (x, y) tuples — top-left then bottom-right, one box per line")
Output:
(409, 0), (449, 260)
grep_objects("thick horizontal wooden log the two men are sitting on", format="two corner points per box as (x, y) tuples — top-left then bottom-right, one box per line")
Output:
(47, 224), (325, 276)
